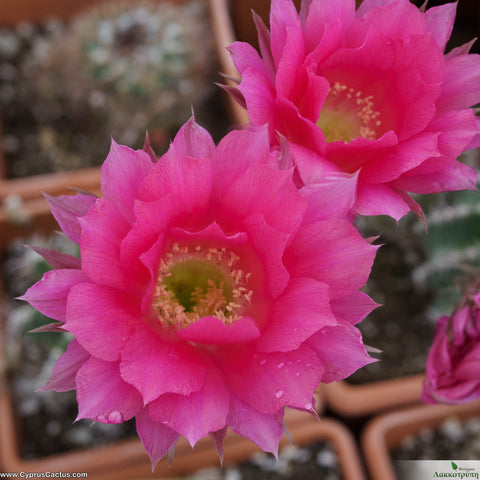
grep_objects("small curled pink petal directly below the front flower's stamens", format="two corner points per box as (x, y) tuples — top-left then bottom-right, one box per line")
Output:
(176, 317), (260, 345)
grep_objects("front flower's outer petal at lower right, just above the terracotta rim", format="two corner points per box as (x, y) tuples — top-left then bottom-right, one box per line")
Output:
(308, 324), (376, 383)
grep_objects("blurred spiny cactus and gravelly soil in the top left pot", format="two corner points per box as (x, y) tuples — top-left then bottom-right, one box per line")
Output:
(0, 0), (218, 176)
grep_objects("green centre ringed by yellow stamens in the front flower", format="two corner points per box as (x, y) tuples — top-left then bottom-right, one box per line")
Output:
(153, 243), (253, 329)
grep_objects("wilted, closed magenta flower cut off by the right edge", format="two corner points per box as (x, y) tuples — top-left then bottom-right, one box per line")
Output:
(422, 292), (480, 404)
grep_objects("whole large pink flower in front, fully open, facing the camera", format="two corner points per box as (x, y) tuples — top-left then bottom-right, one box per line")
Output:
(23, 121), (376, 463)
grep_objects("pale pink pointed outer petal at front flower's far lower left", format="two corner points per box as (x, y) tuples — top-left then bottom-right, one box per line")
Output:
(38, 339), (90, 392)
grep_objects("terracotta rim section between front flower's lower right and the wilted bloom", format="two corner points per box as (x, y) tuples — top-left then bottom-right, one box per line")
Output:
(322, 374), (424, 417)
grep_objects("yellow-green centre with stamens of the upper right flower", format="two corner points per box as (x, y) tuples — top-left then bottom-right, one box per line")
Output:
(317, 82), (382, 143)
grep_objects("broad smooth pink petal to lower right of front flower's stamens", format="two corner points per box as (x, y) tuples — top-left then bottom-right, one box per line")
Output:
(256, 278), (336, 352)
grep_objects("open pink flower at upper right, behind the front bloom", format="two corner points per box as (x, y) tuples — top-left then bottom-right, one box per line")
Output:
(230, 0), (480, 219)
